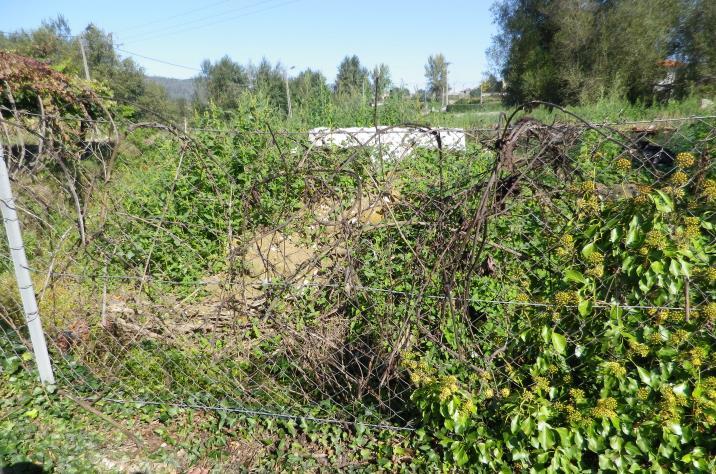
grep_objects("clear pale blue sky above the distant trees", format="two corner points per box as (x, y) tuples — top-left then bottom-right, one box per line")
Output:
(0, 0), (495, 89)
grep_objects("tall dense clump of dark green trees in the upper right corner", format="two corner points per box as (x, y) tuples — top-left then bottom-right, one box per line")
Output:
(488, 0), (716, 104)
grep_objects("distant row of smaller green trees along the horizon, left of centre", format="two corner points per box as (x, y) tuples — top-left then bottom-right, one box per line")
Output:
(0, 15), (458, 123)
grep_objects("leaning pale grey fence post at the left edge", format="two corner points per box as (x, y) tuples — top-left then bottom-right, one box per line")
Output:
(0, 146), (55, 384)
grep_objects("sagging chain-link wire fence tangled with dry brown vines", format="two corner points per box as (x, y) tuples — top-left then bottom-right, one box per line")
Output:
(0, 98), (716, 436)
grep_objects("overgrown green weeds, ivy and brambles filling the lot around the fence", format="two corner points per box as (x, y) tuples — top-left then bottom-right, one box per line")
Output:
(0, 7), (716, 472)
